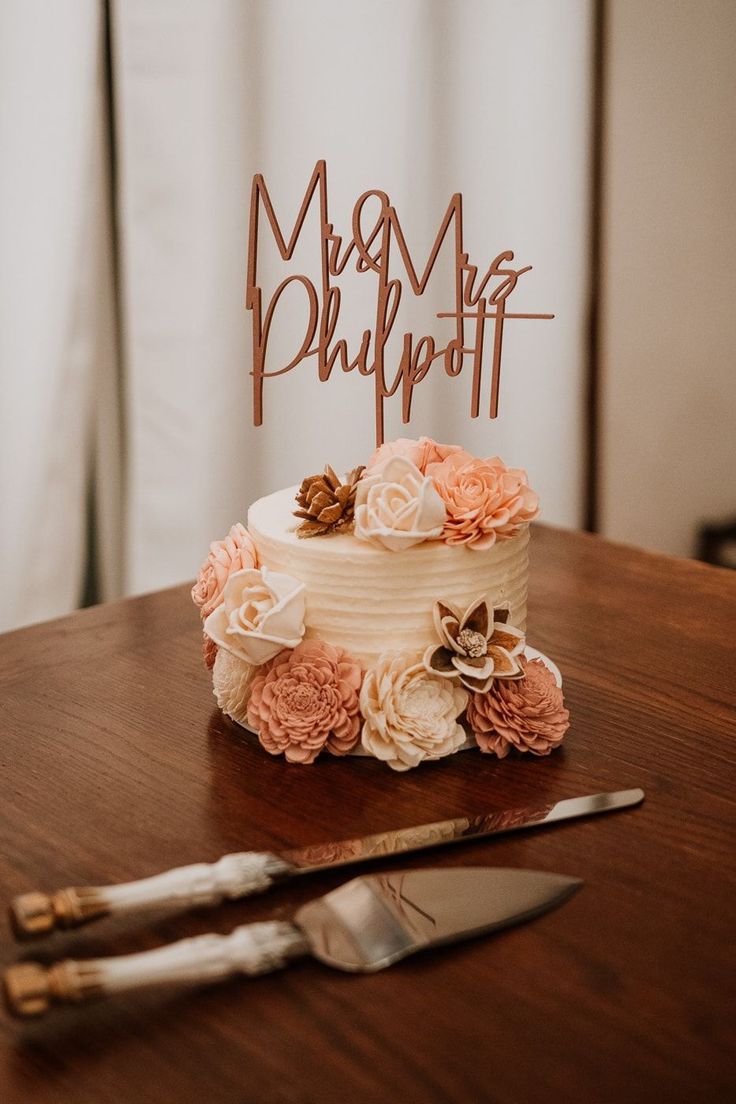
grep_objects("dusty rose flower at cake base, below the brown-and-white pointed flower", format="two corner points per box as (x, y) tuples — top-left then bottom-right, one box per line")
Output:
(466, 657), (569, 758)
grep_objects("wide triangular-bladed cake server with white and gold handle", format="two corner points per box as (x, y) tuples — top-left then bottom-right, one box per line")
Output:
(4, 867), (583, 1016)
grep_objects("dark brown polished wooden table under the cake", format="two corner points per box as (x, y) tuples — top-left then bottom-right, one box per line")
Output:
(0, 528), (736, 1104)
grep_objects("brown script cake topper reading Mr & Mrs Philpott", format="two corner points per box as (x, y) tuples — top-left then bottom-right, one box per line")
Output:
(245, 161), (554, 445)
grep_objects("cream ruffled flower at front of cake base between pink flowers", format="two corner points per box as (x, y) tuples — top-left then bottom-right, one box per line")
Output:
(361, 651), (468, 771)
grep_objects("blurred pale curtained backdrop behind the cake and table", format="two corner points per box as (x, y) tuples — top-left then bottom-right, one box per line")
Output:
(0, 0), (736, 629)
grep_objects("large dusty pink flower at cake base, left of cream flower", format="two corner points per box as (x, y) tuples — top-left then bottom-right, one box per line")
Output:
(248, 640), (363, 763)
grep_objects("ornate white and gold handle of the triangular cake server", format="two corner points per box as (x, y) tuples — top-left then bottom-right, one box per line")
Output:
(4, 921), (309, 1016)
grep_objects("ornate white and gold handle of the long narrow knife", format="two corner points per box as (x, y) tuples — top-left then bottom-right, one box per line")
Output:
(10, 851), (291, 940)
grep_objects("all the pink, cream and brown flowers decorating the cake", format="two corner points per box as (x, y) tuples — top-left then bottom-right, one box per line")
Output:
(192, 437), (568, 771)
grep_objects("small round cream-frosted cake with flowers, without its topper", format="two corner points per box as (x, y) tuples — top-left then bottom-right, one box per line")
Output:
(192, 437), (568, 771)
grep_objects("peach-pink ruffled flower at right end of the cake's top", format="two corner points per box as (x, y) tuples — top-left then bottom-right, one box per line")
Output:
(427, 453), (540, 550)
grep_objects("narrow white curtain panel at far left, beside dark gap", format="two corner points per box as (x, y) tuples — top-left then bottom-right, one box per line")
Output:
(0, 0), (121, 629)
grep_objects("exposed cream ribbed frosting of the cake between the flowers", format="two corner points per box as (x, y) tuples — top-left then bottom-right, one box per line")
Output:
(248, 487), (529, 666)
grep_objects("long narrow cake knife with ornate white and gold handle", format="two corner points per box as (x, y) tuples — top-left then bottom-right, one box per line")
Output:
(10, 789), (644, 940)
